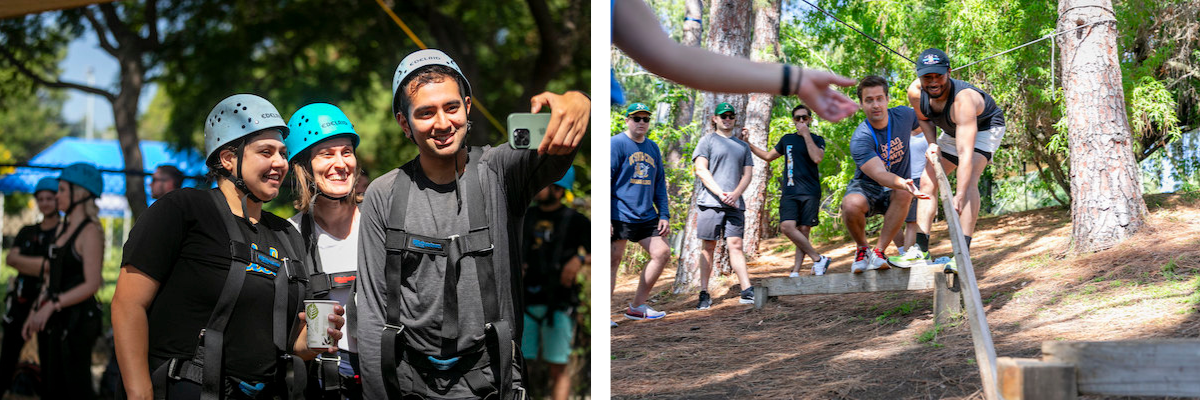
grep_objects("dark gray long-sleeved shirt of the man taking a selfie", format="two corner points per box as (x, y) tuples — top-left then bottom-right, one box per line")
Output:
(352, 145), (575, 399)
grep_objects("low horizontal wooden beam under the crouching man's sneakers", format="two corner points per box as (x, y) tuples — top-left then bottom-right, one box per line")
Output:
(755, 265), (942, 300)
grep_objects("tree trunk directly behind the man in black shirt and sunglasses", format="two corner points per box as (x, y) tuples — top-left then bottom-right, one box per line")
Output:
(742, 0), (780, 257)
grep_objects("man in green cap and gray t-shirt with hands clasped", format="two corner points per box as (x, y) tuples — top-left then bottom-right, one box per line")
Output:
(692, 103), (754, 306)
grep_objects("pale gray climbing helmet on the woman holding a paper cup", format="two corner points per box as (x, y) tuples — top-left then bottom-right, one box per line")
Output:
(204, 94), (288, 165)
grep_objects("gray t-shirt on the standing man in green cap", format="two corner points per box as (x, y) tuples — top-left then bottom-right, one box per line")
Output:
(691, 133), (754, 210)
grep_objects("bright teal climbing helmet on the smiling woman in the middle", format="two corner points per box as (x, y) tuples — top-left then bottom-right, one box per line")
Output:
(283, 103), (359, 162)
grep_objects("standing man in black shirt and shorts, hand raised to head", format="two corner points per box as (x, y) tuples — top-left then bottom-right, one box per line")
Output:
(746, 105), (829, 277)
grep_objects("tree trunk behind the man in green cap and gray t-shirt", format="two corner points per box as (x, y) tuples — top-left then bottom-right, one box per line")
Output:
(674, 0), (752, 293)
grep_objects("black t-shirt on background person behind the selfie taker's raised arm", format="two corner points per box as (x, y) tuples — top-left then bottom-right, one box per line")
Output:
(521, 207), (592, 305)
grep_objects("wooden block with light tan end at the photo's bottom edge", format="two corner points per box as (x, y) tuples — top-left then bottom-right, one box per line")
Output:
(996, 357), (1079, 400)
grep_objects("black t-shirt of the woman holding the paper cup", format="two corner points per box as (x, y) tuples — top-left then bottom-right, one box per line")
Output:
(121, 189), (304, 381)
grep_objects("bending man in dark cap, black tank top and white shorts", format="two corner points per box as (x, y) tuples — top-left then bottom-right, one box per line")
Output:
(902, 48), (1004, 271)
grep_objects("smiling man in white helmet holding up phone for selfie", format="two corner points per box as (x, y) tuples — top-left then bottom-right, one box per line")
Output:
(352, 49), (590, 399)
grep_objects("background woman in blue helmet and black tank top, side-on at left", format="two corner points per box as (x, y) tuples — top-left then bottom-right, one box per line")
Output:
(23, 163), (104, 399)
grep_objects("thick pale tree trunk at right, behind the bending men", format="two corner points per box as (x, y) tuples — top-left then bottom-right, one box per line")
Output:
(1058, 0), (1146, 253)
